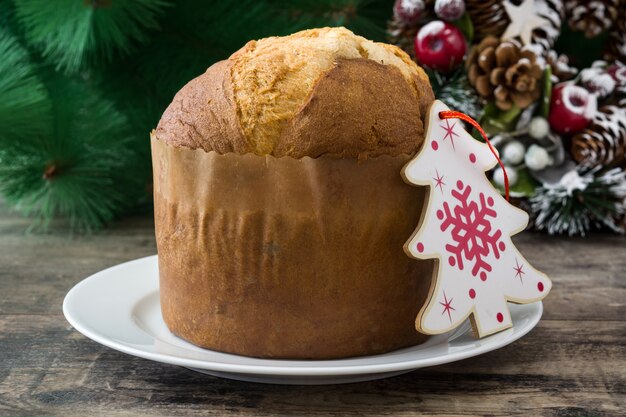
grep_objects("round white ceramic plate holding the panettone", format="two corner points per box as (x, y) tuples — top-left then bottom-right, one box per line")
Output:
(63, 256), (543, 384)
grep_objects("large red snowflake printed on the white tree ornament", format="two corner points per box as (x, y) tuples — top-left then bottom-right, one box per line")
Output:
(437, 181), (505, 281)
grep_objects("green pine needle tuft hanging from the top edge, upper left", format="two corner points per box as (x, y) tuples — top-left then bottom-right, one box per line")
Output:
(14, 0), (168, 72)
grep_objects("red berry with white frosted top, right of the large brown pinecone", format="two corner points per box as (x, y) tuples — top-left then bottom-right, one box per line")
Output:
(548, 83), (597, 134)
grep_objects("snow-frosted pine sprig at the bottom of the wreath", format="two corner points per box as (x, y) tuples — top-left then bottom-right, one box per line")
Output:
(530, 168), (626, 236)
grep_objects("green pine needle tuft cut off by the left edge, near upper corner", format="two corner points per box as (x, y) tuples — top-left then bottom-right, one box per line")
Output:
(0, 29), (51, 143)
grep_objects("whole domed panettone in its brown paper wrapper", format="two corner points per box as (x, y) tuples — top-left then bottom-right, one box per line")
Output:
(152, 28), (434, 359)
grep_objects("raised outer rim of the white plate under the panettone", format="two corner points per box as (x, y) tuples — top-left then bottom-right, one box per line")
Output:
(63, 255), (543, 377)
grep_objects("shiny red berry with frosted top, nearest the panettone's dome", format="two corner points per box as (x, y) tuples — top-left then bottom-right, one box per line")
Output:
(415, 20), (467, 72)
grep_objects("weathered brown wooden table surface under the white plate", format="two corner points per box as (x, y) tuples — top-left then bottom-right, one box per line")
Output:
(0, 209), (626, 417)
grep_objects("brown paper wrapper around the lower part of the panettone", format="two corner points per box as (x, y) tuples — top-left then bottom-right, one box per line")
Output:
(152, 138), (433, 359)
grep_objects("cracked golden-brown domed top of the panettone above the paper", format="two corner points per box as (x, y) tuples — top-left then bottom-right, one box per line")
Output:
(155, 28), (434, 158)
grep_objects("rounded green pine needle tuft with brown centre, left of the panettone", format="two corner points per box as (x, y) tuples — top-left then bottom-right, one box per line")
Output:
(0, 73), (147, 231)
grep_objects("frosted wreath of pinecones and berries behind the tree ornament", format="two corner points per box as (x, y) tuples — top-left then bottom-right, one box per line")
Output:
(389, 0), (626, 234)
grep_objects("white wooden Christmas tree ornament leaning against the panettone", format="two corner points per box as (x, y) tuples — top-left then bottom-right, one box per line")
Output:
(403, 101), (551, 337)
